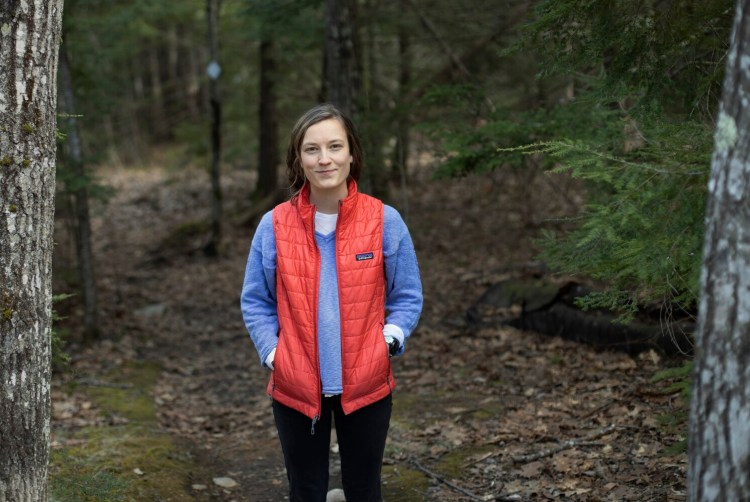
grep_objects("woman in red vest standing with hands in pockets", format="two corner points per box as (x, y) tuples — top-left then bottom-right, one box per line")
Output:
(241, 104), (422, 502)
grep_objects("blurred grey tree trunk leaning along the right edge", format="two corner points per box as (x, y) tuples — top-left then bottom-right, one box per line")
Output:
(688, 0), (750, 501)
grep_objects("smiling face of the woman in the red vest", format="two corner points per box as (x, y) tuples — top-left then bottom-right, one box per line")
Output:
(300, 118), (352, 199)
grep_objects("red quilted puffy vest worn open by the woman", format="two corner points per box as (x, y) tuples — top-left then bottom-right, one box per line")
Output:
(268, 180), (395, 419)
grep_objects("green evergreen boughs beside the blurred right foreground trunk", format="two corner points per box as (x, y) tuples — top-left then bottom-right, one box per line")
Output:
(434, 0), (731, 319)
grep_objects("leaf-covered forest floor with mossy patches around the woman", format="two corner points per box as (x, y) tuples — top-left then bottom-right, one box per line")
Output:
(51, 163), (687, 502)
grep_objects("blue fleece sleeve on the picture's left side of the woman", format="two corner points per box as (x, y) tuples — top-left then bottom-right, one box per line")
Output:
(240, 211), (279, 364)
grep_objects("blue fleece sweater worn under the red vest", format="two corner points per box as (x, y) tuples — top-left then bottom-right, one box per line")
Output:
(241, 205), (422, 394)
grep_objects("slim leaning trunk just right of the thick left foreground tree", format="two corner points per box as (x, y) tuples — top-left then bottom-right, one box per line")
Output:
(60, 48), (99, 341)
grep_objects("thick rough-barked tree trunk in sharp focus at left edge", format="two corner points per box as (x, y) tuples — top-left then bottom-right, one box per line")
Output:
(0, 0), (63, 502)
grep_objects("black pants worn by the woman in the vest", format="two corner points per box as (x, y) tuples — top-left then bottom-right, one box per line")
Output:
(273, 395), (393, 502)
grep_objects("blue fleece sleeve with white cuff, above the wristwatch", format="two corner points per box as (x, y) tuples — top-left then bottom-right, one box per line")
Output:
(383, 205), (422, 354)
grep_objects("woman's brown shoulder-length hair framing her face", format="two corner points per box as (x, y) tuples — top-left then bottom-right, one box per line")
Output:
(286, 103), (362, 199)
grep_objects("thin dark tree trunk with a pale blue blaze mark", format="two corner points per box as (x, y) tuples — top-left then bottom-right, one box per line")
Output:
(205, 0), (222, 256)
